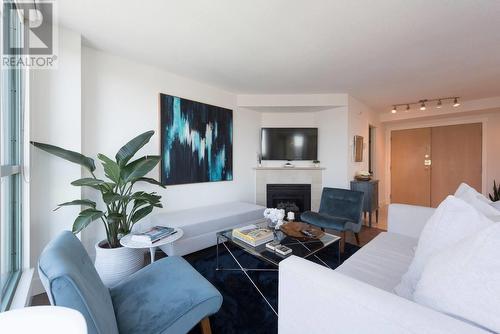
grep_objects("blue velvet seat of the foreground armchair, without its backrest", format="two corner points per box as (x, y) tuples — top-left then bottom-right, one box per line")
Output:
(111, 256), (222, 334)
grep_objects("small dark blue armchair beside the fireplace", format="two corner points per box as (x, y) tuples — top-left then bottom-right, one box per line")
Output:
(300, 188), (364, 252)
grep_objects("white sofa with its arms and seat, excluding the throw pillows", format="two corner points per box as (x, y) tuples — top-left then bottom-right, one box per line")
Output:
(278, 204), (490, 334)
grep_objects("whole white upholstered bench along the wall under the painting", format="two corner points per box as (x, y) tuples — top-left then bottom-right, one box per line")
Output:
(146, 202), (265, 256)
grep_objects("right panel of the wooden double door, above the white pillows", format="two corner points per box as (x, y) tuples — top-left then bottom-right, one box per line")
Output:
(431, 123), (483, 207)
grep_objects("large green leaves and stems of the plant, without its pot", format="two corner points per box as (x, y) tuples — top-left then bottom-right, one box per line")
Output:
(31, 131), (165, 248)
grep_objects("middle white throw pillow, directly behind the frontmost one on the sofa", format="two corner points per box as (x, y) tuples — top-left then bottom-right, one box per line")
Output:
(394, 196), (493, 299)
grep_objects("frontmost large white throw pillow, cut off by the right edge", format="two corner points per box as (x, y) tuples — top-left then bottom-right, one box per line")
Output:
(413, 224), (500, 333)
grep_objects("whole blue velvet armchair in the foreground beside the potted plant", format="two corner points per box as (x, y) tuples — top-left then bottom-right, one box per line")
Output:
(38, 231), (222, 334)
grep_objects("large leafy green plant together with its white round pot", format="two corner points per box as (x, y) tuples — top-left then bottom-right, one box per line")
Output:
(31, 131), (165, 286)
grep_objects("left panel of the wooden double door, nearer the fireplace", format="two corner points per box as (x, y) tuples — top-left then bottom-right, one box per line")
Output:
(391, 128), (431, 206)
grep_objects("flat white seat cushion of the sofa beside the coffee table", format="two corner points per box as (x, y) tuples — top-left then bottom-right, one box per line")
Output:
(335, 232), (418, 293)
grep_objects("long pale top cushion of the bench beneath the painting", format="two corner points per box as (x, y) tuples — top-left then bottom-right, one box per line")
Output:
(151, 202), (265, 239)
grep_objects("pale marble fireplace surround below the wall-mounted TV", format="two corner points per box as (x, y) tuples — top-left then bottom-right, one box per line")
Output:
(255, 167), (324, 211)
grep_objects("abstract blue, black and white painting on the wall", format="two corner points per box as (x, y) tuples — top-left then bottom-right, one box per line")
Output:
(159, 94), (233, 185)
